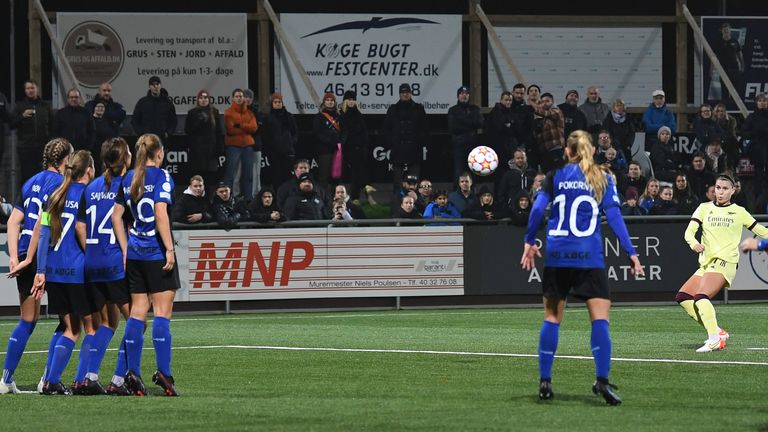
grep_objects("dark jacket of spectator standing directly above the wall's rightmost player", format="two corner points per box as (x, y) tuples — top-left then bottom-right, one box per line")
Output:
(131, 89), (177, 139)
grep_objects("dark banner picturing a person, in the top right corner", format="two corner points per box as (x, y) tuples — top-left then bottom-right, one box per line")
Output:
(701, 17), (768, 111)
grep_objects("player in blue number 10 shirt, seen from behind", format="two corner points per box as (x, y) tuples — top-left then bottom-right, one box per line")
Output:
(520, 130), (644, 405)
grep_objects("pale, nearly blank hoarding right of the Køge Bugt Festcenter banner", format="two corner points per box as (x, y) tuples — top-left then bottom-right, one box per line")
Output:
(488, 26), (662, 107)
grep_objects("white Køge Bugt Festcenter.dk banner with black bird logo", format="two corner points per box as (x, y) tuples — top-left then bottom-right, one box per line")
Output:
(275, 14), (463, 114)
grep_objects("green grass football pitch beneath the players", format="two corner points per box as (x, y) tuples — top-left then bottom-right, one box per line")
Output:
(0, 304), (768, 432)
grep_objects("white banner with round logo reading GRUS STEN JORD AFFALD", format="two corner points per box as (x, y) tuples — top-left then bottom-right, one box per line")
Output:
(56, 12), (248, 114)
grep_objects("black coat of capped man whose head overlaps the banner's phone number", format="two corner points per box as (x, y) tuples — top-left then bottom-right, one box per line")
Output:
(383, 100), (429, 164)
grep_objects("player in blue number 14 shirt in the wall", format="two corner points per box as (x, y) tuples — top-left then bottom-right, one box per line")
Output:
(75, 137), (131, 396)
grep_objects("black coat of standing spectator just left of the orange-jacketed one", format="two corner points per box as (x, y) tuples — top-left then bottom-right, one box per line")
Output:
(184, 106), (224, 174)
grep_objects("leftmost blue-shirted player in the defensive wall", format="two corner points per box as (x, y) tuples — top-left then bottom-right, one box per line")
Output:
(0, 138), (72, 394)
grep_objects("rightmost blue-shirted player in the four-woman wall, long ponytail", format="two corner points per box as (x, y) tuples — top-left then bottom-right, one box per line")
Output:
(112, 134), (180, 396)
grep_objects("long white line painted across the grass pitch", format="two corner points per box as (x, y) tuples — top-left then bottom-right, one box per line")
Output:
(3, 345), (768, 366)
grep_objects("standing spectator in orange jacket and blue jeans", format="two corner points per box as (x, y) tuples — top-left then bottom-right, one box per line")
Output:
(224, 89), (258, 201)
